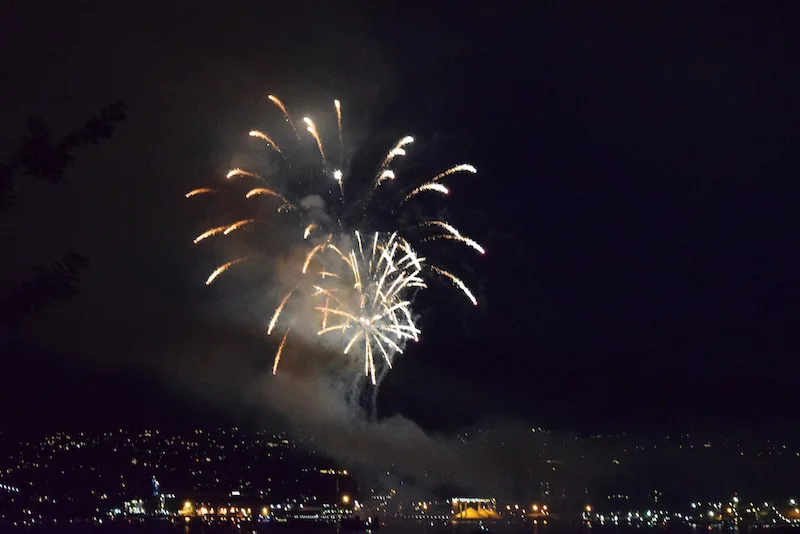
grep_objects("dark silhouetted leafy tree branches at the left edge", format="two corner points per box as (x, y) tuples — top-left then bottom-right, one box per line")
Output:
(0, 102), (127, 325)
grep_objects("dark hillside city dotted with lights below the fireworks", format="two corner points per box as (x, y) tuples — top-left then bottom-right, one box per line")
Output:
(0, 427), (800, 526)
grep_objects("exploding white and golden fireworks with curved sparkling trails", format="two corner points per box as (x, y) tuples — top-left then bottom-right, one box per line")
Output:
(186, 95), (485, 384)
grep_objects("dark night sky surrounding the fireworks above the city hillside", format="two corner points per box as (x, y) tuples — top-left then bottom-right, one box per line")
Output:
(0, 0), (800, 440)
